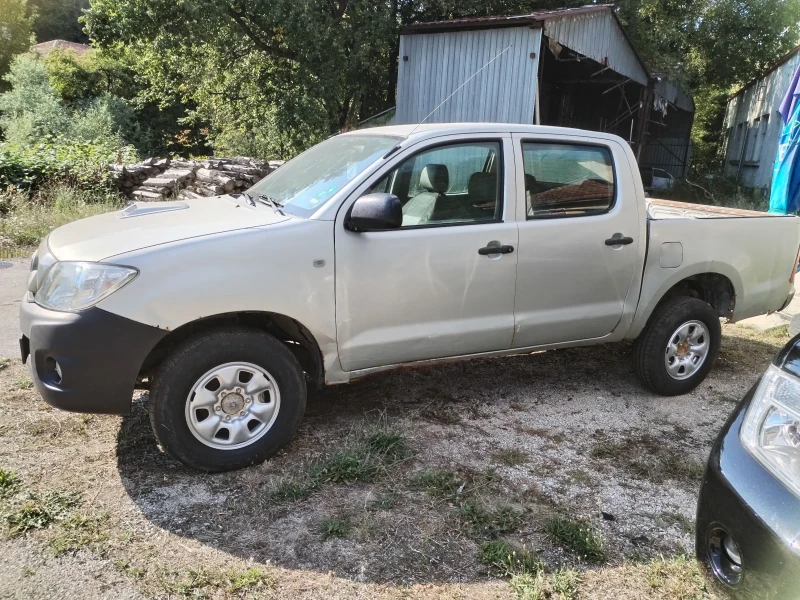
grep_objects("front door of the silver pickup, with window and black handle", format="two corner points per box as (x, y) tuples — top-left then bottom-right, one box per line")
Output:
(335, 136), (517, 371)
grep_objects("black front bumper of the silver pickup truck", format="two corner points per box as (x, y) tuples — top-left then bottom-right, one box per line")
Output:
(20, 298), (167, 414)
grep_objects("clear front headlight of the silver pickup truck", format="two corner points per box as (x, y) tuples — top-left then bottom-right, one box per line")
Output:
(34, 262), (139, 312)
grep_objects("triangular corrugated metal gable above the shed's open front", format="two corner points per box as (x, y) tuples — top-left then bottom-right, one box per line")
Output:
(539, 6), (649, 85)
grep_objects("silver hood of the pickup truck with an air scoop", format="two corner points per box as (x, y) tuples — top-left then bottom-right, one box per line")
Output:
(47, 196), (290, 261)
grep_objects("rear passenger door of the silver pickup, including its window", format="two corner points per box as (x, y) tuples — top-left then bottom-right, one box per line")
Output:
(513, 134), (646, 348)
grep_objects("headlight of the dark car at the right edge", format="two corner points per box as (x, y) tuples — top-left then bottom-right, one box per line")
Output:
(740, 366), (800, 496)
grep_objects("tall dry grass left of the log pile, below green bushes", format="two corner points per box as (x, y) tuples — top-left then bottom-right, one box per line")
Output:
(0, 185), (124, 256)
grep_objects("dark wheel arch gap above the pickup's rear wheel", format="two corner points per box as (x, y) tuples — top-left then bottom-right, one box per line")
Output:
(627, 271), (737, 338)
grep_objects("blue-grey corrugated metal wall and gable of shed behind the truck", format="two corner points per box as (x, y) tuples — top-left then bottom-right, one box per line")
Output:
(394, 4), (648, 123)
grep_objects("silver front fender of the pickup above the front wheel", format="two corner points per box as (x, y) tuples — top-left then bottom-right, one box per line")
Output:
(98, 219), (338, 378)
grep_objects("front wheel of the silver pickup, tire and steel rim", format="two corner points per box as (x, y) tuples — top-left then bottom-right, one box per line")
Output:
(149, 328), (306, 473)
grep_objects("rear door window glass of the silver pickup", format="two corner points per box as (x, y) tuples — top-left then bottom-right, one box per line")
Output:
(522, 142), (614, 219)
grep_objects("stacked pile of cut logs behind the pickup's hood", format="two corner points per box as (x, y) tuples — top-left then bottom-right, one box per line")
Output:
(109, 156), (283, 201)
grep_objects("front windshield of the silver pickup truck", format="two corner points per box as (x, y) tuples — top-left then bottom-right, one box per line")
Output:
(247, 135), (400, 217)
